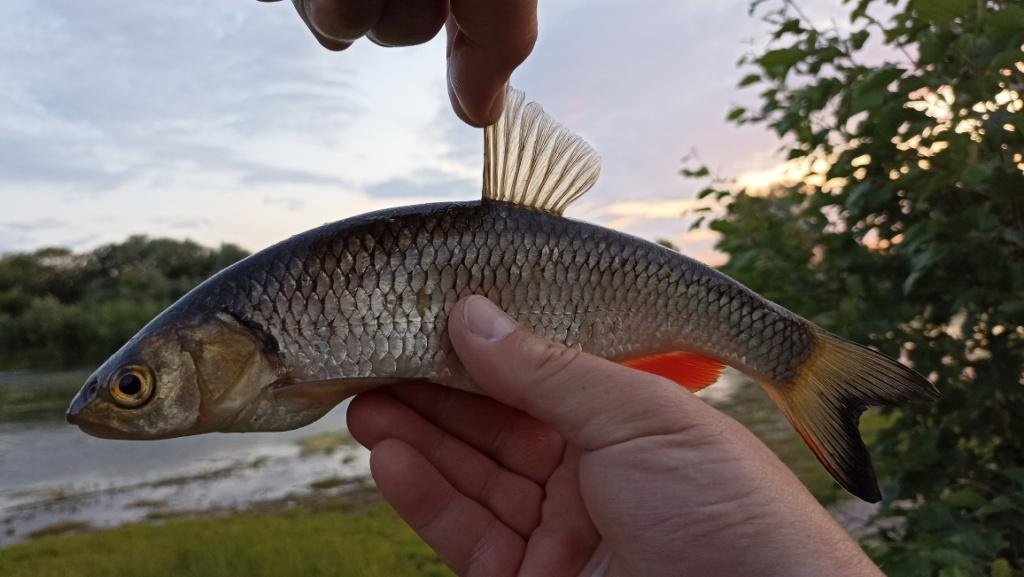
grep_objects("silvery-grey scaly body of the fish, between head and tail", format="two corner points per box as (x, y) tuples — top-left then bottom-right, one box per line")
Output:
(197, 201), (811, 381)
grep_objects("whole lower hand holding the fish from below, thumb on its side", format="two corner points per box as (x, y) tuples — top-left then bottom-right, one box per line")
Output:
(348, 296), (881, 577)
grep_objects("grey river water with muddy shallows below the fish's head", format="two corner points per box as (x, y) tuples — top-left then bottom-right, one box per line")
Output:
(0, 372), (369, 546)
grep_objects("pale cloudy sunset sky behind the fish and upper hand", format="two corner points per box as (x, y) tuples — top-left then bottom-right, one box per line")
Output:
(0, 0), (806, 263)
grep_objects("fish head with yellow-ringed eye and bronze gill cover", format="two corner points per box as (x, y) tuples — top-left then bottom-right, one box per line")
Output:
(67, 307), (280, 440)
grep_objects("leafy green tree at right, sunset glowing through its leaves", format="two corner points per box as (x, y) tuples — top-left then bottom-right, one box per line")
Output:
(684, 0), (1024, 577)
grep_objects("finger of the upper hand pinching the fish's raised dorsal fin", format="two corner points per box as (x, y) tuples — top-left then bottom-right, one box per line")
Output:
(449, 0), (537, 126)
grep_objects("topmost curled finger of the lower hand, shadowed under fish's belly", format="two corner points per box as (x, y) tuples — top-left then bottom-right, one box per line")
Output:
(388, 383), (565, 484)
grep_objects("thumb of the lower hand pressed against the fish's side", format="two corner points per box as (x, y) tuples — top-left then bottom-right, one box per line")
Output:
(449, 295), (713, 450)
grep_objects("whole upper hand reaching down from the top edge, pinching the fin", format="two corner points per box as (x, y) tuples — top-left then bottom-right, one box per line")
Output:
(262, 0), (537, 126)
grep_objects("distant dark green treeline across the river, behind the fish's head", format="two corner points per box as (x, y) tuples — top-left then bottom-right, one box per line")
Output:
(0, 237), (248, 369)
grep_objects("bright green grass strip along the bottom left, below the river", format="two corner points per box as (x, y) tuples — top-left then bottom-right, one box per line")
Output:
(0, 500), (452, 577)
